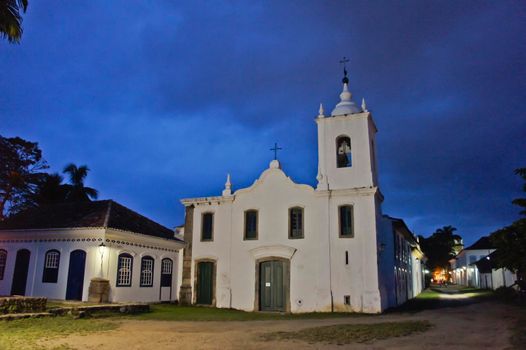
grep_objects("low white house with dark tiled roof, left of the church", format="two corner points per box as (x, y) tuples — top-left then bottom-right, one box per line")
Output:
(0, 200), (184, 302)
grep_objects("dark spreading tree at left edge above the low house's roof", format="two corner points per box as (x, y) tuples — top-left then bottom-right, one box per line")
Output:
(0, 136), (48, 221)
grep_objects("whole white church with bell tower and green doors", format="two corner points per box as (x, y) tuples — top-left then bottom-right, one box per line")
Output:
(180, 72), (423, 313)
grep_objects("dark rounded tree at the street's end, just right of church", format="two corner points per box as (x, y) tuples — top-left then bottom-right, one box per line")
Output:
(420, 226), (462, 270)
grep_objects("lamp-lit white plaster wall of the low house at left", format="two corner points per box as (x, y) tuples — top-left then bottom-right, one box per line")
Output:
(0, 228), (185, 302)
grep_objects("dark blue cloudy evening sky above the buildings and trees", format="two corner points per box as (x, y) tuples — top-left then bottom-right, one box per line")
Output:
(0, 1), (526, 244)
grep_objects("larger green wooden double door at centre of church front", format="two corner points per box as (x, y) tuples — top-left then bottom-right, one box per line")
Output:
(259, 260), (285, 312)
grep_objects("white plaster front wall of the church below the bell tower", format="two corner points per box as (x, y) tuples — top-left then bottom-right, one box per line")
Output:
(192, 165), (381, 312)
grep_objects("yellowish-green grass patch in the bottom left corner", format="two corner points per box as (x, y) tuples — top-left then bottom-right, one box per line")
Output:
(0, 317), (119, 350)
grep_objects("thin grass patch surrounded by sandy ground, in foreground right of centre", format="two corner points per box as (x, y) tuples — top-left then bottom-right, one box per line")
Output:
(263, 321), (431, 345)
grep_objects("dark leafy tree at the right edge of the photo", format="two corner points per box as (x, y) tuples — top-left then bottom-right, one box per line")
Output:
(490, 168), (526, 284)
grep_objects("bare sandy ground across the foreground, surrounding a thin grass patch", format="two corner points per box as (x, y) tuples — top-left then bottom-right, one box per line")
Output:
(46, 301), (517, 350)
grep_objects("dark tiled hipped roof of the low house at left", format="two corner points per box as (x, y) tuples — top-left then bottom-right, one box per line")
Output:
(0, 200), (180, 241)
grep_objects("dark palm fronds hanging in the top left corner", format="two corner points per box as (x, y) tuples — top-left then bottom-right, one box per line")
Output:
(0, 0), (28, 43)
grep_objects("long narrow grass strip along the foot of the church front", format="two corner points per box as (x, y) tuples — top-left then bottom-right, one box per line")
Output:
(129, 304), (363, 321)
